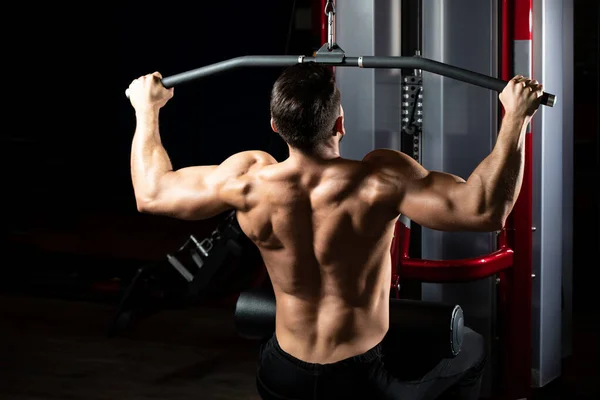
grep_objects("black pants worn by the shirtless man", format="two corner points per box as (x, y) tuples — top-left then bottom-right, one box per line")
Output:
(256, 328), (486, 400)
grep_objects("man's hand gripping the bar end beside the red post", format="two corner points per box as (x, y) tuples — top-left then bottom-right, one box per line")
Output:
(499, 75), (544, 118)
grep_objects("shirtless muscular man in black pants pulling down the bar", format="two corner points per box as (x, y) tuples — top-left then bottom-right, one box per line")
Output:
(129, 63), (542, 399)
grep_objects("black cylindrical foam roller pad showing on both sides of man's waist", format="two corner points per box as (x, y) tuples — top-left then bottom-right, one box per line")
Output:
(235, 289), (464, 358)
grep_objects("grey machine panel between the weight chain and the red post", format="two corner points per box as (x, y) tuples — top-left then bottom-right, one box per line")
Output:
(421, 0), (498, 394)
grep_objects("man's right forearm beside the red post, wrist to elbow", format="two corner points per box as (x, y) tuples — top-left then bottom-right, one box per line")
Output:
(467, 114), (529, 222)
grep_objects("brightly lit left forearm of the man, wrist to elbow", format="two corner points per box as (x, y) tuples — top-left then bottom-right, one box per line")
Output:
(131, 110), (173, 205)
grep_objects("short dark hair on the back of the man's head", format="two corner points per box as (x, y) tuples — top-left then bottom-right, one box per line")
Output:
(271, 62), (340, 151)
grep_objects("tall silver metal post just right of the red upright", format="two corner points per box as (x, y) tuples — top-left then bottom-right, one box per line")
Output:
(531, 0), (573, 386)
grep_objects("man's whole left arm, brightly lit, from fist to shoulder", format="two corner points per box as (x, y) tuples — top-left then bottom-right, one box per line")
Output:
(129, 73), (275, 220)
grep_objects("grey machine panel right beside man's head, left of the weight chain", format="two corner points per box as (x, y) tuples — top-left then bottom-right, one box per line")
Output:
(335, 0), (401, 160)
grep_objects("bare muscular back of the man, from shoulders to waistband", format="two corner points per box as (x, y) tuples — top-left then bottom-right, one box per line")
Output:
(238, 155), (398, 363)
